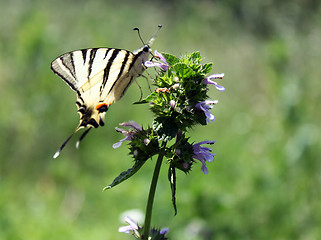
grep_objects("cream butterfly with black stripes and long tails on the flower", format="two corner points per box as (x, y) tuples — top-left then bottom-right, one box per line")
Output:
(51, 25), (161, 158)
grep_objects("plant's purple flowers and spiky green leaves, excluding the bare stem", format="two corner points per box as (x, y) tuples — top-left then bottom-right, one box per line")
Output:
(105, 51), (225, 239)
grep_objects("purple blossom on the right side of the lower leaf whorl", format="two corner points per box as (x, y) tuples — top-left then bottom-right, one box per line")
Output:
(193, 141), (216, 174)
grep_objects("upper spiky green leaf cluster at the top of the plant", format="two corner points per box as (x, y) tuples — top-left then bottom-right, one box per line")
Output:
(138, 52), (212, 139)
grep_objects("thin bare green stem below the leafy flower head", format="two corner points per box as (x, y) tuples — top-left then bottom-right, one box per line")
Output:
(143, 141), (166, 240)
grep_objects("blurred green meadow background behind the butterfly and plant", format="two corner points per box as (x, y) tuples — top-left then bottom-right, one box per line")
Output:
(0, 0), (321, 240)
